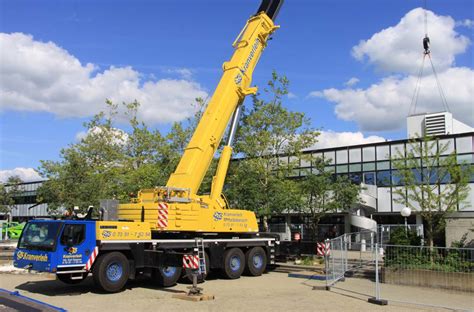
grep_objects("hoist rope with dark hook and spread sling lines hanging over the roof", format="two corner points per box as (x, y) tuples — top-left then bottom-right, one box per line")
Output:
(408, 0), (450, 115)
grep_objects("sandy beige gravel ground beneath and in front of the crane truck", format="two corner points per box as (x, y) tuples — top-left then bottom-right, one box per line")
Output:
(0, 272), (474, 312)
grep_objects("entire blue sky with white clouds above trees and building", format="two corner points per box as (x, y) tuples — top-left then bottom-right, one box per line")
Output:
(0, 0), (474, 181)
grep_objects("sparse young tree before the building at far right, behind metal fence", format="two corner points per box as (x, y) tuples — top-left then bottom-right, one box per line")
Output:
(391, 136), (472, 247)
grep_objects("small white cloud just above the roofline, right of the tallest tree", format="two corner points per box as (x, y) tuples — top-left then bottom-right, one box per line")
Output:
(310, 131), (385, 149)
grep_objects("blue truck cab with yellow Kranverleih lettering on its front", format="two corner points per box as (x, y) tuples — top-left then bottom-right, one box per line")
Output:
(13, 220), (96, 279)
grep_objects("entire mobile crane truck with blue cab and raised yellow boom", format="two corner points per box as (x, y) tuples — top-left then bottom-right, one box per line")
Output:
(14, 0), (283, 292)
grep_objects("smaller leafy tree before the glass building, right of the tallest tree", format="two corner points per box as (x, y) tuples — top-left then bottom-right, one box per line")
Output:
(300, 157), (361, 240)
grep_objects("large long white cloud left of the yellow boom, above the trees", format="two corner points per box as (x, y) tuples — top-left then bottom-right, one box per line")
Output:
(0, 33), (207, 123)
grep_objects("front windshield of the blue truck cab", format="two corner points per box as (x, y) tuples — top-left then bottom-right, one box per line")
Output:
(18, 222), (61, 251)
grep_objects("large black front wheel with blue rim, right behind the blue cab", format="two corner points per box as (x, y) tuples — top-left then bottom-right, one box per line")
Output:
(92, 251), (130, 292)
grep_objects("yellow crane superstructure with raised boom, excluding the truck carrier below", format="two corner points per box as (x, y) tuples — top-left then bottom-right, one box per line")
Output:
(119, 1), (281, 233)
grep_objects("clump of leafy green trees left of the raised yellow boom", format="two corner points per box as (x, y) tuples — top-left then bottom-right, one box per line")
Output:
(38, 99), (204, 212)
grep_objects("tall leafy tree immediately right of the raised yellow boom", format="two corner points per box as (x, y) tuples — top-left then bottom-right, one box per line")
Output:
(227, 71), (318, 230)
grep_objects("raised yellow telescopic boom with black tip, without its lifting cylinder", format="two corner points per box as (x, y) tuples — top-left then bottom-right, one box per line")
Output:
(166, 0), (283, 195)
